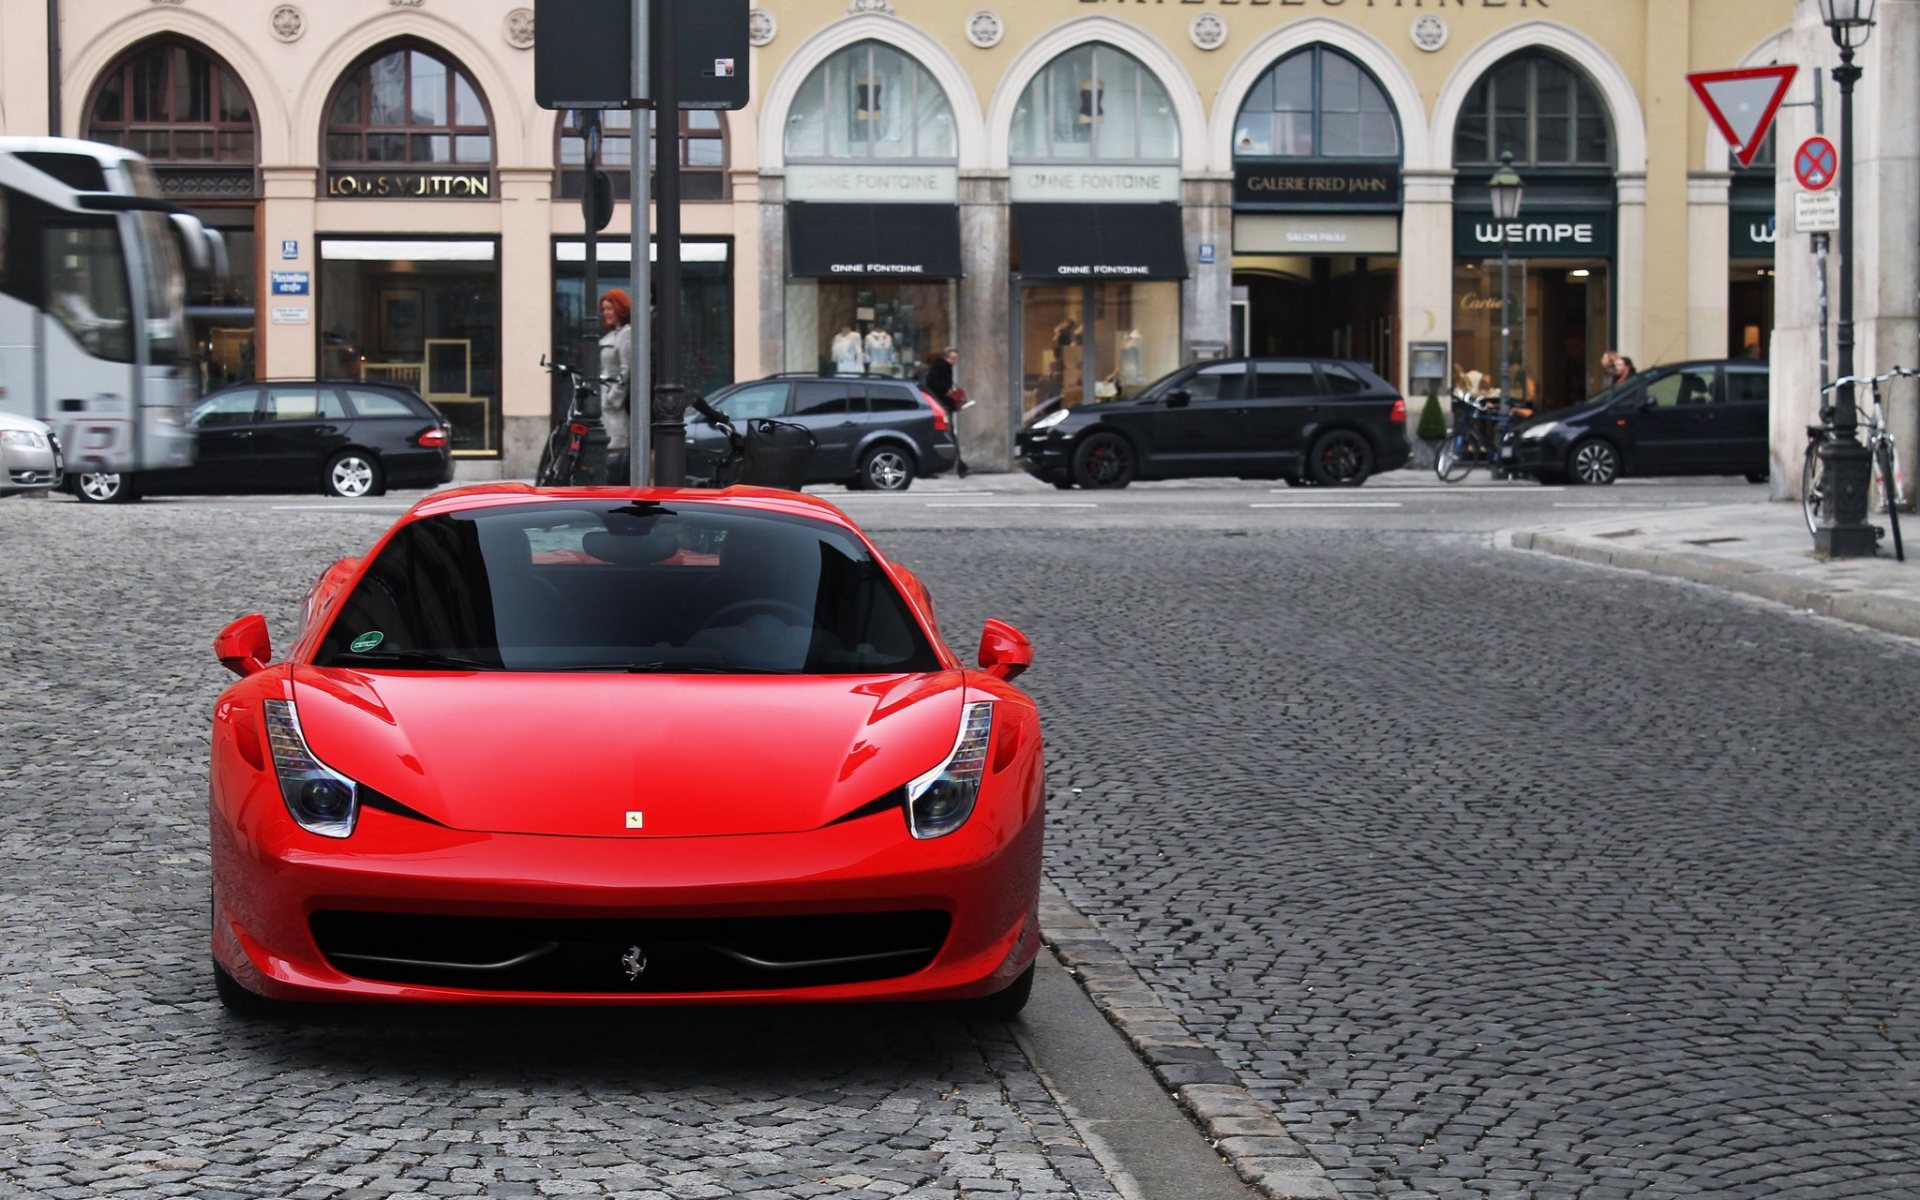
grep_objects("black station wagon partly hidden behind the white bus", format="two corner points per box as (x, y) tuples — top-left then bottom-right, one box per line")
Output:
(67, 380), (453, 505)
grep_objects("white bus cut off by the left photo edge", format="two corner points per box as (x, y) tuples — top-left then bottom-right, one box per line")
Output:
(0, 138), (227, 470)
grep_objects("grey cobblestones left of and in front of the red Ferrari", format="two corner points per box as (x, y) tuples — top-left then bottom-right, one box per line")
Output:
(0, 501), (1117, 1200)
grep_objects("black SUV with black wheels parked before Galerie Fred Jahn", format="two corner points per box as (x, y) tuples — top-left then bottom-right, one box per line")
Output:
(1016, 359), (1409, 488)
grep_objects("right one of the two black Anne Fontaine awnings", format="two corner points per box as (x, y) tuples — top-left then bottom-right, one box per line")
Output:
(1014, 204), (1187, 282)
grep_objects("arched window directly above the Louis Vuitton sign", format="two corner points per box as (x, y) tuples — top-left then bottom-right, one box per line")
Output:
(326, 46), (493, 167)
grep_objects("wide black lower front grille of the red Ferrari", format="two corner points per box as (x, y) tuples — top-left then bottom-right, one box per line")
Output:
(311, 912), (952, 995)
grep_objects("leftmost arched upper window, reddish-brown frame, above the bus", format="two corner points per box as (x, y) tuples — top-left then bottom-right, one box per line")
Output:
(86, 38), (255, 163)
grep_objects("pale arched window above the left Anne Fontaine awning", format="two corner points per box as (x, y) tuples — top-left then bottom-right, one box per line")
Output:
(785, 42), (958, 163)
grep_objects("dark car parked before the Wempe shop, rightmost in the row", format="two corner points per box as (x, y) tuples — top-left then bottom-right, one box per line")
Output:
(1507, 359), (1768, 484)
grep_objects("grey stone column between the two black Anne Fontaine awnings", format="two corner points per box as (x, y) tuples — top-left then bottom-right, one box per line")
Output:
(954, 175), (1020, 470)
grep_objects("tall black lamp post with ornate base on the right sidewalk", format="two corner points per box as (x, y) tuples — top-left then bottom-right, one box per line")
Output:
(1812, 0), (1876, 559)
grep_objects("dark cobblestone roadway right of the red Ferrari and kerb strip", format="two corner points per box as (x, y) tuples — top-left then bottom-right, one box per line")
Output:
(877, 516), (1920, 1200)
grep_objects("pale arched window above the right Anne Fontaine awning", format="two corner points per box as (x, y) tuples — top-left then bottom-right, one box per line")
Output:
(1008, 42), (1181, 163)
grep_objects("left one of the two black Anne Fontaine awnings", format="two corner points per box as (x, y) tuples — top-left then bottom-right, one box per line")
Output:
(787, 204), (960, 278)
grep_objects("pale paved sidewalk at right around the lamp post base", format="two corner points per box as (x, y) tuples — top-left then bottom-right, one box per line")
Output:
(1513, 499), (1920, 637)
